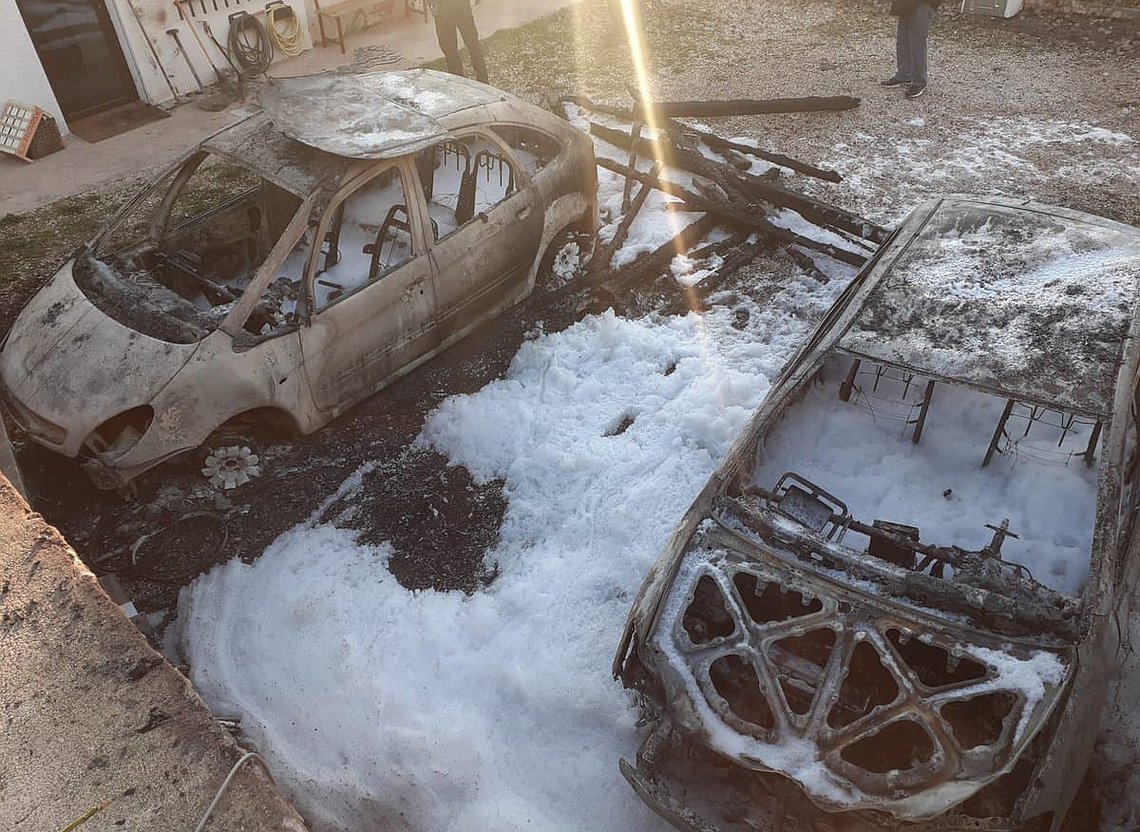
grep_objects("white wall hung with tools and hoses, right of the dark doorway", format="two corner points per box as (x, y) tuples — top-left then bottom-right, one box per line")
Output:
(105, 0), (312, 105)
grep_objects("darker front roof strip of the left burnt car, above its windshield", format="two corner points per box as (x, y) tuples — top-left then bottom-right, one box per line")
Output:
(202, 113), (348, 198)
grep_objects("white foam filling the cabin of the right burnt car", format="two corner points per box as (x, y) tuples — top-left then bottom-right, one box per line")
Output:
(754, 361), (1097, 597)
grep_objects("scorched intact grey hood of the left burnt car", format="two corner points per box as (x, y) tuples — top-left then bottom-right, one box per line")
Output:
(0, 262), (198, 439)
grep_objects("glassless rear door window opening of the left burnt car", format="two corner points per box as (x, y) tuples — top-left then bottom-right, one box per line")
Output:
(416, 131), (518, 240)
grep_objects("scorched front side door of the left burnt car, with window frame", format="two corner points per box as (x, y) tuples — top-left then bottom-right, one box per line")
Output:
(301, 156), (439, 416)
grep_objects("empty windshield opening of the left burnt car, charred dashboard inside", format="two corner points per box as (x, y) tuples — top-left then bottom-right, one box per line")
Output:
(74, 152), (301, 343)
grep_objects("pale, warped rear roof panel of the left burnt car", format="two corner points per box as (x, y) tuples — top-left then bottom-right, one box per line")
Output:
(260, 70), (507, 160)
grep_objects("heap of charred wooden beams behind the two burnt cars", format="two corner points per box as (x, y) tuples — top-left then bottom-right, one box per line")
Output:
(561, 96), (889, 305)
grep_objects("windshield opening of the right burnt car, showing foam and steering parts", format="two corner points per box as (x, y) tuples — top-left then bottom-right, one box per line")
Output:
(751, 358), (1101, 597)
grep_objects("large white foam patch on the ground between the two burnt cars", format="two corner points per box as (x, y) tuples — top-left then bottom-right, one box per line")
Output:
(180, 294), (842, 831)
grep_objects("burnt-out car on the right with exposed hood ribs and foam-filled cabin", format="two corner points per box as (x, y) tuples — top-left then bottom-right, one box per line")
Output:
(614, 196), (1140, 832)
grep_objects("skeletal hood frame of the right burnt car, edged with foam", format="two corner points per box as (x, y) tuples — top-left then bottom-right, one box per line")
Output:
(648, 499), (1074, 821)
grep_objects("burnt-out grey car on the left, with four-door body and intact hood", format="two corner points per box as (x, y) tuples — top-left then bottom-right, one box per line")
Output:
(0, 70), (597, 487)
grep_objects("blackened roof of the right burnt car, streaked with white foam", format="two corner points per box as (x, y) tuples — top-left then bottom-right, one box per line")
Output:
(839, 196), (1140, 416)
